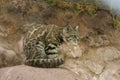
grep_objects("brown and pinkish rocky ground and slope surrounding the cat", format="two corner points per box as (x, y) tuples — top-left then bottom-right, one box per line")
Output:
(0, 0), (120, 80)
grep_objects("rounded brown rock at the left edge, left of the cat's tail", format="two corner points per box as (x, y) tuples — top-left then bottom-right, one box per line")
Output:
(0, 46), (22, 67)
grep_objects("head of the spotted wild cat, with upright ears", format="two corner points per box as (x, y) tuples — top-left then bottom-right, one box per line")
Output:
(62, 25), (79, 44)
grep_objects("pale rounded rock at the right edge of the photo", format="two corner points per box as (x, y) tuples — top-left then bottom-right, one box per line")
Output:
(96, 47), (120, 61)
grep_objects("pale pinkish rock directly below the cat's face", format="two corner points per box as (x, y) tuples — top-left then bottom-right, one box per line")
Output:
(58, 43), (85, 59)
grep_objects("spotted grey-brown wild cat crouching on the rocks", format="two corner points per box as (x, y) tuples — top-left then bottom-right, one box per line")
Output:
(23, 24), (78, 68)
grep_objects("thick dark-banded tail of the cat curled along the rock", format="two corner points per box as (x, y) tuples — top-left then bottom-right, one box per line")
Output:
(25, 58), (64, 68)
